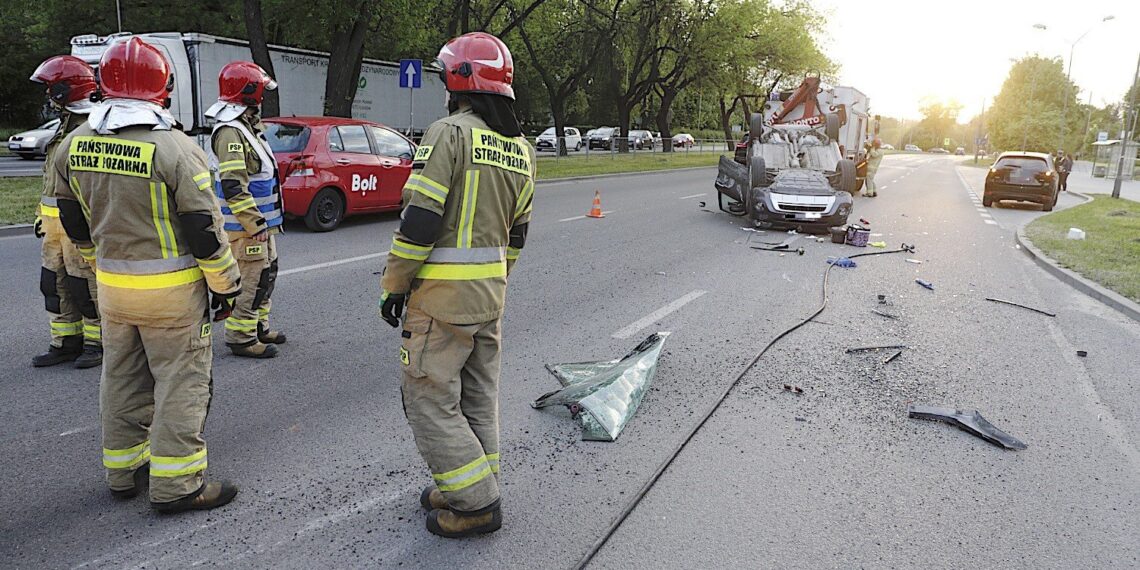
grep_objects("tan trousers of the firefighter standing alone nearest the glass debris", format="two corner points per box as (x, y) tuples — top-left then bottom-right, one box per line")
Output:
(400, 309), (500, 513)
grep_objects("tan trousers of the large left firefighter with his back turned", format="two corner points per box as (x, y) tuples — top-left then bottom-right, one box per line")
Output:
(99, 316), (213, 503)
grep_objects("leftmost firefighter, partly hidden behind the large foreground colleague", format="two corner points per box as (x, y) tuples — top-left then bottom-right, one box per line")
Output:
(31, 56), (103, 368)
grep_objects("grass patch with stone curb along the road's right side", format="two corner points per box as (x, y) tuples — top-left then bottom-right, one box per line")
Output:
(1018, 196), (1140, 320)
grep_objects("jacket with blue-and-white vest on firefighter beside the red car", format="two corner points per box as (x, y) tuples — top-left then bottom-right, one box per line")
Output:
(210, 119), (283, 236)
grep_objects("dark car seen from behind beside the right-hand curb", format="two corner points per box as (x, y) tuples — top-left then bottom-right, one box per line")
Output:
(982, 153), (1058, 212)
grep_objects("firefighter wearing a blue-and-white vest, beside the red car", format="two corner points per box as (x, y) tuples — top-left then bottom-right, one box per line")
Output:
(206, 62), (285, 358)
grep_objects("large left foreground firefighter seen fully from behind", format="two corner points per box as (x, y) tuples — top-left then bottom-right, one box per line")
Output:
(50, 38), (241, 513)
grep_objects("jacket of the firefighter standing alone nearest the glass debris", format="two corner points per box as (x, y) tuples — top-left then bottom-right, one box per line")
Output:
(381, 109), (535, 324)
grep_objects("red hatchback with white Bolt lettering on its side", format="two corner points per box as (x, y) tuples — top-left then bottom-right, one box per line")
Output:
(264, 116), (416, 231)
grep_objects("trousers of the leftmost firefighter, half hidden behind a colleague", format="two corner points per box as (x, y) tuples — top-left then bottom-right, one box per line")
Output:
(40, 214), (103, 348)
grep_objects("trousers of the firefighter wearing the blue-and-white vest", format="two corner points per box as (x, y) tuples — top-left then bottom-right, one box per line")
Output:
(226, 233), (277, 347)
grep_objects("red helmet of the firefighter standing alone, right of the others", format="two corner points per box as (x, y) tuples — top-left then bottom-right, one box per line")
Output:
(435, 32), (514, 99)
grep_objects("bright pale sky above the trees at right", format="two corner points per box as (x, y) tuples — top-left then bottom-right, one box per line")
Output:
(811, 0), (1140, 122)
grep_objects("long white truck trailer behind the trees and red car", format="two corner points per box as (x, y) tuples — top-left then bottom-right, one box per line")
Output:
(71, 32), (447, 138)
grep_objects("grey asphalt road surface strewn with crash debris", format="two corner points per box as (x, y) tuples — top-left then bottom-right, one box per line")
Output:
(0, 155), (1140, 568)
